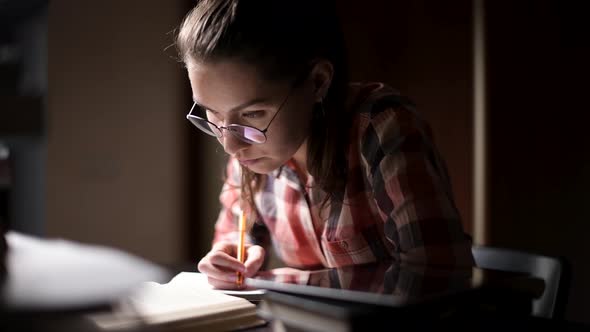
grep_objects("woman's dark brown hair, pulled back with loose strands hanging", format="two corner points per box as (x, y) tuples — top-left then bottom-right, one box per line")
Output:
(176, 0), (348, 223)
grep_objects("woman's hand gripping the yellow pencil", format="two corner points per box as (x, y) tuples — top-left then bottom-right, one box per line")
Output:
(198, 242), (265, 289)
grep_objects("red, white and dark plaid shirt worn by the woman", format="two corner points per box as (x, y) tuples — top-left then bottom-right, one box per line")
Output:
(213, 83), (474, 268)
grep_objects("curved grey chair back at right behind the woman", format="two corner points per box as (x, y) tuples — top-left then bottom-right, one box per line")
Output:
(472, 246), (571, 319)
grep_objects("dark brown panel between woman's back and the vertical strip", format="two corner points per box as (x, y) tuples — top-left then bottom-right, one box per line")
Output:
(337, 0), (473, 233)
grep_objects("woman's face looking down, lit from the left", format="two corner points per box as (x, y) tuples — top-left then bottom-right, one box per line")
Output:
(187, 61), (315, 174)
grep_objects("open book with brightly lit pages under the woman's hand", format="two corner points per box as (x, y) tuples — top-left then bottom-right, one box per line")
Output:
(89, 272), (264, 331)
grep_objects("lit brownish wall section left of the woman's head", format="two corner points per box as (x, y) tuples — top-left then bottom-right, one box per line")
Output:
(45, 0), (190, 264)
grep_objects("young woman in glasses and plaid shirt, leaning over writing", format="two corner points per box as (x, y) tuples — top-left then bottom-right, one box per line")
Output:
(176, 0), (473, 288)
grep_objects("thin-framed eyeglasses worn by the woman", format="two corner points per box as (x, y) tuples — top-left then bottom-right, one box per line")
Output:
(186, 80), (299, 144)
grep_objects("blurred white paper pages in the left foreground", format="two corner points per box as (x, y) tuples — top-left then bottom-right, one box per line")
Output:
(1, 232), (169, 310)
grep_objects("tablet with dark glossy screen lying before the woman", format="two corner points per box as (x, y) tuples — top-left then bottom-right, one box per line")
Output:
(246, 262), (475, 307)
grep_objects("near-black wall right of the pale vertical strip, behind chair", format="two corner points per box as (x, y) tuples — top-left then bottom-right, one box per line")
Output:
(486, 1), (590, 322)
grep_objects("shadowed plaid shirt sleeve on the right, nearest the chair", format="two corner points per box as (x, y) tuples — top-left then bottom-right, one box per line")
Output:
(361, 107), (473, 266)
